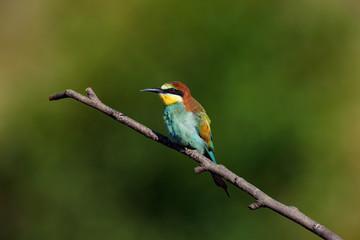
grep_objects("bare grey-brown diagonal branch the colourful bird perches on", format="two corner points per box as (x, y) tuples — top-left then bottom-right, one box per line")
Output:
(49, 88), (342, 240)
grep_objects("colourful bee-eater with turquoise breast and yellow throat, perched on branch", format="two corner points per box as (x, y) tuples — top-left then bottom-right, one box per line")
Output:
(140, 81), (230, 196)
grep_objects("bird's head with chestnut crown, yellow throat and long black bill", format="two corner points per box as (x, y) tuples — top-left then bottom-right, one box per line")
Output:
(141, 81), (190, 105)
